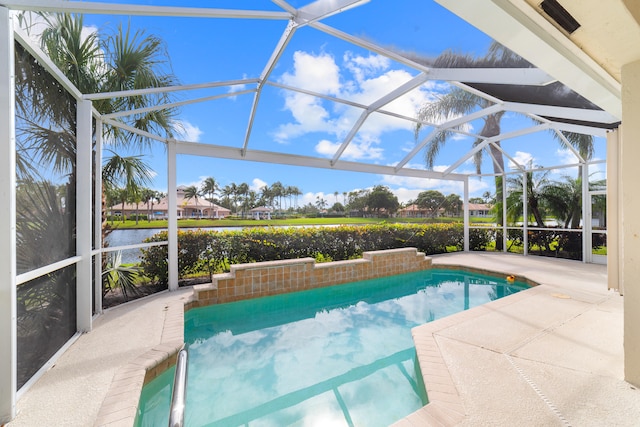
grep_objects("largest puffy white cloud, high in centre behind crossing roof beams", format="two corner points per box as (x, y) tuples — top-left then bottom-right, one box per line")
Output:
(273, 51), (435, 160)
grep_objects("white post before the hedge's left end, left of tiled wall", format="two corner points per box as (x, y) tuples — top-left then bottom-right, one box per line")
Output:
(167, 139), (178, 291)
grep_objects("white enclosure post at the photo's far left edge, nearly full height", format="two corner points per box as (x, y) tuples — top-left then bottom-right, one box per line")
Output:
(0, 6), (17, 424)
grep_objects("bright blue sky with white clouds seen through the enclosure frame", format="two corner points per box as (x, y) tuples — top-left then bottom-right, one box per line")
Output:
(55, 0), (604, 205)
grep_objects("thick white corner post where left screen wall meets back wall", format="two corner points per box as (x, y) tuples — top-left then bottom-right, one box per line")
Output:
(76, 100), (93, 332)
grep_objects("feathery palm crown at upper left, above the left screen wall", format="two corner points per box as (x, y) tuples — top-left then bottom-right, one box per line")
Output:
(36, 14), (177, 150)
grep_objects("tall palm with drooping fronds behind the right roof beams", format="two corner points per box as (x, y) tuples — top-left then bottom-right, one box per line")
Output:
(415, 42), (593, 250)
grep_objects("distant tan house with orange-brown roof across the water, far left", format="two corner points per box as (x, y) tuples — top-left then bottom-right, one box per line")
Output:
(111, 186), (231, 219)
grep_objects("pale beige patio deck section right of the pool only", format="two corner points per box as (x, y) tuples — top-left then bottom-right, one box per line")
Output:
(393, 253), (640, 427)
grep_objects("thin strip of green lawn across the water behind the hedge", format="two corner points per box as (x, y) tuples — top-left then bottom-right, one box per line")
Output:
(108, 217), (492, 229)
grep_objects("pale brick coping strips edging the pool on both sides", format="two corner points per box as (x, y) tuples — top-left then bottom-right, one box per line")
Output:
(94, 257), (538, 427)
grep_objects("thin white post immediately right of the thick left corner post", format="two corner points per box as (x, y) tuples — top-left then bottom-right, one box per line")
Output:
(93, 119), (104, 313)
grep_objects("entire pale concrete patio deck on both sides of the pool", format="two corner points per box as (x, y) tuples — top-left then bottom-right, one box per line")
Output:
(8, 252), (640, 427)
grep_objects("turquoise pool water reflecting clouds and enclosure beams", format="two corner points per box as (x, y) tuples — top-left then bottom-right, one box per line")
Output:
(136, 270), (527, 427)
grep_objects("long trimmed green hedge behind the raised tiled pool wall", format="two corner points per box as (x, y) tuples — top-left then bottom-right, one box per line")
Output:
(141, 224), (489, 283)
